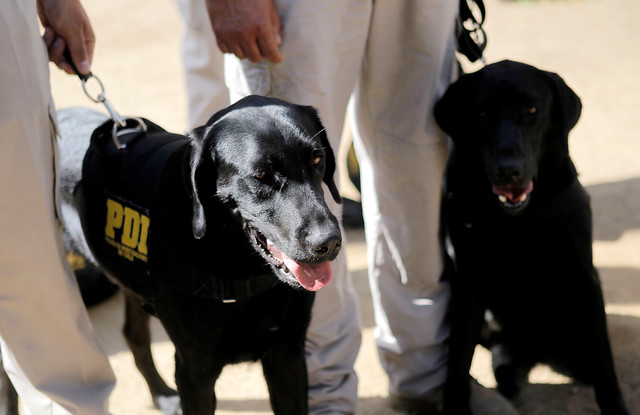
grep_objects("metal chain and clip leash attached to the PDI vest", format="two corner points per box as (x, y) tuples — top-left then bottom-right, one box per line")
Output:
(64, 48), (147, 150)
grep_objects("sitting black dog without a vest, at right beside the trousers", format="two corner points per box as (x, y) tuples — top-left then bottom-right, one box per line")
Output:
(435, 61), (628, 415)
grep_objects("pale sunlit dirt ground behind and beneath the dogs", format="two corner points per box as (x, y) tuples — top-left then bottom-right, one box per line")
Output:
(46, 0), (640, 415)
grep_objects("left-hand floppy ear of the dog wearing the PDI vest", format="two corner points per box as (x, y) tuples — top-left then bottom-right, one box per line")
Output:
(188, 126), (215, 239)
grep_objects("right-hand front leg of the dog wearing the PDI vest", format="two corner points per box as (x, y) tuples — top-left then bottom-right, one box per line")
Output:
(262, 341), (309, 415)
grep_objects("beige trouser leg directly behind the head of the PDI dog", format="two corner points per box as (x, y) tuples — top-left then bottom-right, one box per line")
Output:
(225, 0), (370, 415)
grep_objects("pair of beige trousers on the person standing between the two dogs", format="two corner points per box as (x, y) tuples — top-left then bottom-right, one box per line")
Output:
(180, 0), (458, 415)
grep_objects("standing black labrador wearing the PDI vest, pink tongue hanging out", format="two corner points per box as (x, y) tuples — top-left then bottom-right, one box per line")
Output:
(12, 96), (342, 415)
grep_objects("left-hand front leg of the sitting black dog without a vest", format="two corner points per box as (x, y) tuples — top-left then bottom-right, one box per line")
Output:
(443, 268), (485, 415)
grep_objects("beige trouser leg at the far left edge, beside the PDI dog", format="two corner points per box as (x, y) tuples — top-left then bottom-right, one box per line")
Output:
(0, 1), (115, 415)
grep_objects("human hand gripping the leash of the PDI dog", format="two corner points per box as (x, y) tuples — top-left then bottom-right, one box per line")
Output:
(38, 0), (96, 75)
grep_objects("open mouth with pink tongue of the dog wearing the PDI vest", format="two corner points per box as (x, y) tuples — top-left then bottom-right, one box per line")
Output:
(250, 228), (333, 291)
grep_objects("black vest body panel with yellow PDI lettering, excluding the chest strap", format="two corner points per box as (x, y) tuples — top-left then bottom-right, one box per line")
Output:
(82, 120), (188, 291)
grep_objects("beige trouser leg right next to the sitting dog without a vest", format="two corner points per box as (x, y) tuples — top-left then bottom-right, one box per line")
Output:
(352, 0), (458, 397)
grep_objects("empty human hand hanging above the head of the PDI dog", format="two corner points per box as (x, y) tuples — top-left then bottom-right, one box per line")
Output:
(206, 0), (282, 63)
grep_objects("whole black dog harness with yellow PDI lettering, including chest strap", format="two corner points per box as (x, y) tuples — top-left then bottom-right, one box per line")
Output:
(82, 119), (277, 302)
